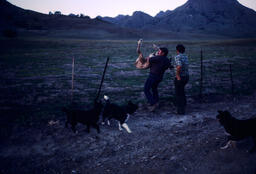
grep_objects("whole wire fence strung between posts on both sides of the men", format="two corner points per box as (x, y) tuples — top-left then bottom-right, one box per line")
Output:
(68, 50), (256, 102)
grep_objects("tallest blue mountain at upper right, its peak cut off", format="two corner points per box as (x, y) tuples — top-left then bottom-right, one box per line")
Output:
(156, 0), (256, 35)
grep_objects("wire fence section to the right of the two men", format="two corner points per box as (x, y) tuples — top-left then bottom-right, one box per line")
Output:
(183, 51), (256, 97)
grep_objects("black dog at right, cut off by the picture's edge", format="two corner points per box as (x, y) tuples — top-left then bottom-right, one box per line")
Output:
(216, 111), (256, 152)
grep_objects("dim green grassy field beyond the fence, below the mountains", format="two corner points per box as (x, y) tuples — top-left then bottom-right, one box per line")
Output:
(0, 37), (256, 123)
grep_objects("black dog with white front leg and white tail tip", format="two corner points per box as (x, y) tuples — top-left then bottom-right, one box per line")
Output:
(102, 95), (138, 133)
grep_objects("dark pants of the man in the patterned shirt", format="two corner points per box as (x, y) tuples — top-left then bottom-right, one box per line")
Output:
(174, 76), (189, 112)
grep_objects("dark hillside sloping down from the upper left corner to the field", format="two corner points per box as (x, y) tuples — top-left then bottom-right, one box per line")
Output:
(0, 0), (146, 39)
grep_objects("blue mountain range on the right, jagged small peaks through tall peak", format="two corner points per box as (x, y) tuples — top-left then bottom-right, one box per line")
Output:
(99, 0), (256, 37)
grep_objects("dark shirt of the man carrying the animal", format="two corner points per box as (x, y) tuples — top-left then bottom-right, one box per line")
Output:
(149, 56), (170, 78)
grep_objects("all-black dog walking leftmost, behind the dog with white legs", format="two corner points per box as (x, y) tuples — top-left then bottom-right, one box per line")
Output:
(62, 102), (103, 133)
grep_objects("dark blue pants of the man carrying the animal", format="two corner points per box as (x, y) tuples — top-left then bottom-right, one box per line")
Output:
(144, 74), (162, 105)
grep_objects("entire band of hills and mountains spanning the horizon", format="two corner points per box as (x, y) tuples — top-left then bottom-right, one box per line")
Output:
(0, 0), (256, 39)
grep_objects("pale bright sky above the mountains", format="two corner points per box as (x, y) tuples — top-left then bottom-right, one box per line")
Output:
(8, 0), (256, 18)
